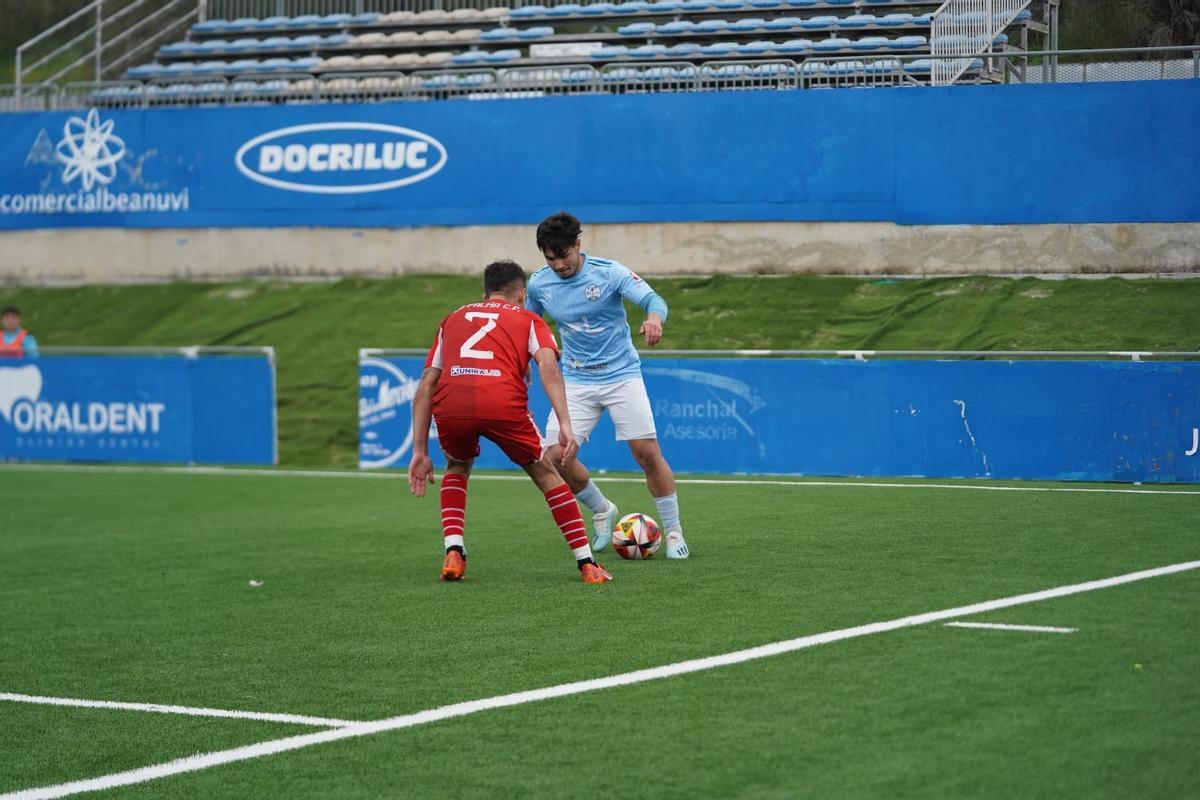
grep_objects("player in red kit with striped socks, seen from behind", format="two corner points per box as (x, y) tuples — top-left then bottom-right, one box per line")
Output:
(408, 260), (612, 583)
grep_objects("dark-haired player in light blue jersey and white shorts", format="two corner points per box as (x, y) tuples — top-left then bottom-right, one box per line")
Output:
(526, 211), (689, 559)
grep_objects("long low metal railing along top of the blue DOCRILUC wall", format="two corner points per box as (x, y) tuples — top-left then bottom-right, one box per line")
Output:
(11, 46), (1200, 112)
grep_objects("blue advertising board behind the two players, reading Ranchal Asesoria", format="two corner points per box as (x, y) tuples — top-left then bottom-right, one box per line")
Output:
(360, 357), (1200, 483)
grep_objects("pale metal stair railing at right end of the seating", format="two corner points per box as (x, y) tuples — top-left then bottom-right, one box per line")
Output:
(930, 0), (1030, 86)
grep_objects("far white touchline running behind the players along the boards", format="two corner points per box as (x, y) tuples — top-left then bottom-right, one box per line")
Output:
(0, 464), (1200, 497)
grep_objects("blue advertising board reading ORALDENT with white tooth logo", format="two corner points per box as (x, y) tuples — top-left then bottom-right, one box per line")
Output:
(0, 355), (276, 464)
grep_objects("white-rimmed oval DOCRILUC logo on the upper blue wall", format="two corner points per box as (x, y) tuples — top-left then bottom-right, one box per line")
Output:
(235, 122), (446, 194)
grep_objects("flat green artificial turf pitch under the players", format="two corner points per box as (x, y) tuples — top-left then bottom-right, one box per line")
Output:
(0, 467), (1200, 798)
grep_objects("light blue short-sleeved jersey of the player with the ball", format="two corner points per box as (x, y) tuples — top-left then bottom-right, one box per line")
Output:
(526, 253), (667, 384)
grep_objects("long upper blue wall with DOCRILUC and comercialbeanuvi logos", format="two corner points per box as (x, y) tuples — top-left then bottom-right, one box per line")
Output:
(0, 80), (1200, 230)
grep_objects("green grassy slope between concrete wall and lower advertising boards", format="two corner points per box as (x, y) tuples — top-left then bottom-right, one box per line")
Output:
(0, 276), (1200, 467)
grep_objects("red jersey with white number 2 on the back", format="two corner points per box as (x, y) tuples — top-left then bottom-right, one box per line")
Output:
(425, 300), (558, 420)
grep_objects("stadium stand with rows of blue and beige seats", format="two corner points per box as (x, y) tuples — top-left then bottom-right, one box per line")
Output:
(42, 0), (1054, 106)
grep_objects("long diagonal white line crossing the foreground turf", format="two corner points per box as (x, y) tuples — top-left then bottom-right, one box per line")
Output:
(0, 561), (1200, 800)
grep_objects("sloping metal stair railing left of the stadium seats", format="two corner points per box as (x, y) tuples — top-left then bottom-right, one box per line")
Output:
(14, 0), (204, 95)
